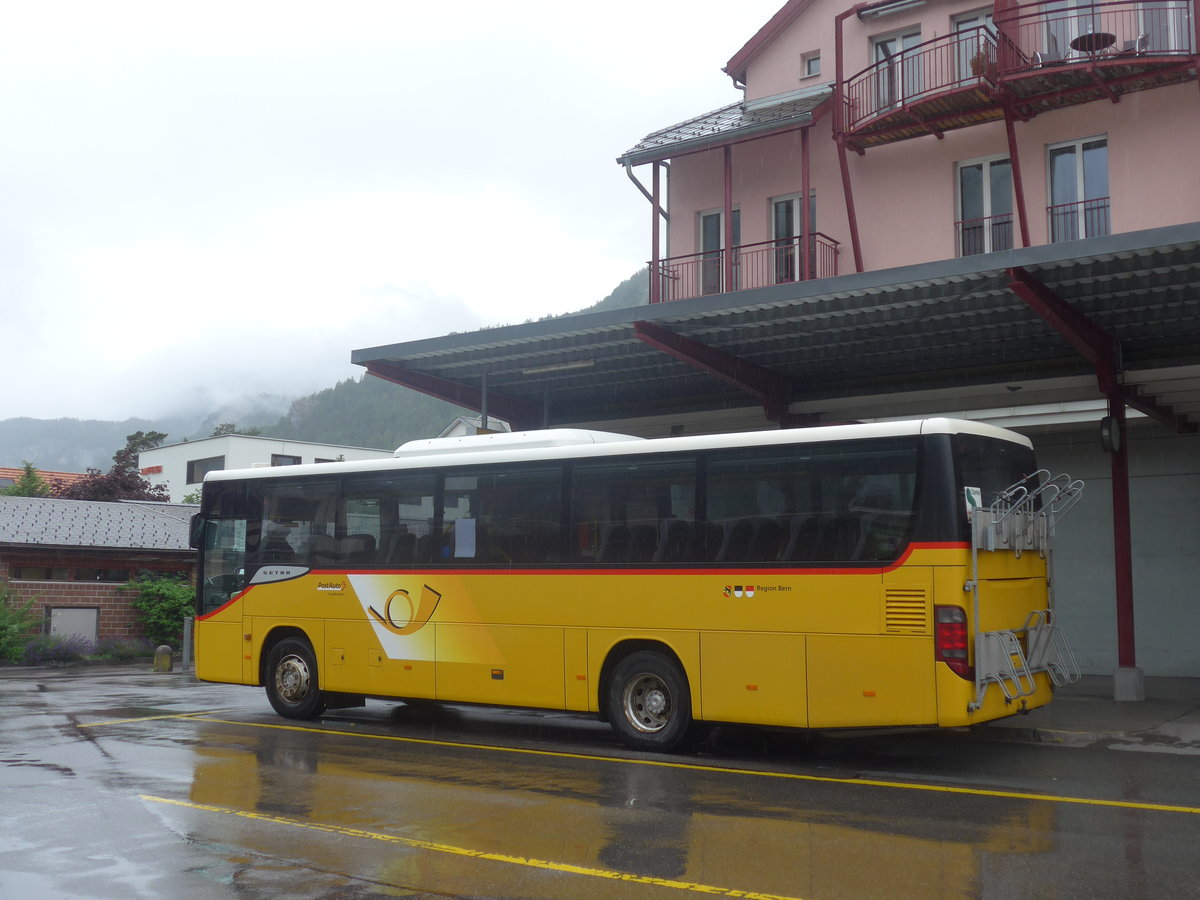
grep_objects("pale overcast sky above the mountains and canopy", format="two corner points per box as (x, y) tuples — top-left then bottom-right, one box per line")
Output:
(0, 0), (782, 419)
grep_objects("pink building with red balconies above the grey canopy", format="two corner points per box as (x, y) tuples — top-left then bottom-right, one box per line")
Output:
(619, 0), (1200, 302)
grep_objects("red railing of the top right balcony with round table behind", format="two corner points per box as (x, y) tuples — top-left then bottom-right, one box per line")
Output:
(996, 0), (1195, 76)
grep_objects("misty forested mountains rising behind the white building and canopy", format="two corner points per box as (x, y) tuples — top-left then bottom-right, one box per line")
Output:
(0, 269), (649, 472)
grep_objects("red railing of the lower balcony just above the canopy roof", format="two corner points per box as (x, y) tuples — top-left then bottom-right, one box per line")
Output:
(650, 232), (838, 302)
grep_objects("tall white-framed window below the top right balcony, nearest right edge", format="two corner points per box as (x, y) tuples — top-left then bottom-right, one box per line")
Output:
(1048, 138), (1110, 244)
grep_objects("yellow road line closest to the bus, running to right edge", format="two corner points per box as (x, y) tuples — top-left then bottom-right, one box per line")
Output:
(184, 714), (1200, 816)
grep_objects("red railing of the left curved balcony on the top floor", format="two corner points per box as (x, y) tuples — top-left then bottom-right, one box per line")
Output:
(845, 25), (998, 131)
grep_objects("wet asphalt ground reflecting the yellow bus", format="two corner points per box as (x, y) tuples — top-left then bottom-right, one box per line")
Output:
(7, 673), (1200, 899)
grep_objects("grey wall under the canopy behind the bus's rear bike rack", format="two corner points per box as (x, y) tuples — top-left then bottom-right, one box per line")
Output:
(1034, 425), (1200, 677)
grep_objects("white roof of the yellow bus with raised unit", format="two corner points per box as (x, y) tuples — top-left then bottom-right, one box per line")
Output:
(204, 419), (1033, 482)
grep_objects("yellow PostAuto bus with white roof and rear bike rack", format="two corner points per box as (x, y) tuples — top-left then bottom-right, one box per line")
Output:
(192, 419), (1082, 751)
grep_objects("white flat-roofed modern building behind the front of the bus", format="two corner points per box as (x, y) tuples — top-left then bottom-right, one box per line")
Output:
(138, 434), (392, 503)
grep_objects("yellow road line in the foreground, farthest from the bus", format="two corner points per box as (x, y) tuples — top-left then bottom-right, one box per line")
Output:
(139, 796), (799, 900)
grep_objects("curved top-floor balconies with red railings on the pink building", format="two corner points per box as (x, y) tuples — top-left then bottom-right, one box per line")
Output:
(840, 0), (1196, 151)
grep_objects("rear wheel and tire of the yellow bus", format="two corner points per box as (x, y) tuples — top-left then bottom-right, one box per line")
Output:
(607, 650), (692, 752)
